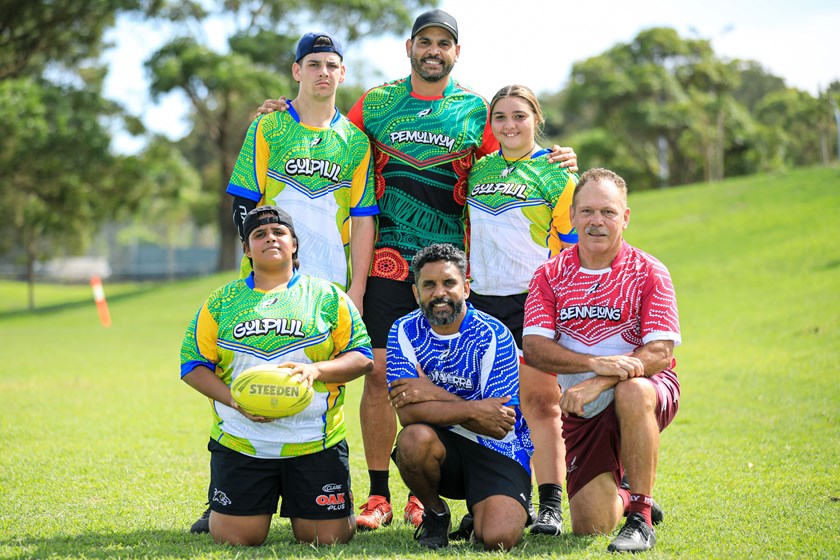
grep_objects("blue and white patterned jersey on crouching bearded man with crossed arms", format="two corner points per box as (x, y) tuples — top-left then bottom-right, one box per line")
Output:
(387, 303), (534, 473)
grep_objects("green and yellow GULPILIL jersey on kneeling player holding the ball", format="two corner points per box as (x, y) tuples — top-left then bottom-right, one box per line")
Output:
(181, 271), (373, 459)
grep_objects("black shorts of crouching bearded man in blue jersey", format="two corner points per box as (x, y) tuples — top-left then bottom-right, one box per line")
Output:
(391, 426), (531, 520)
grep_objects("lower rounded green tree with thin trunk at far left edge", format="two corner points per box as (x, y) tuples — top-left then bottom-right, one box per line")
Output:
(0, 73), (144, 306)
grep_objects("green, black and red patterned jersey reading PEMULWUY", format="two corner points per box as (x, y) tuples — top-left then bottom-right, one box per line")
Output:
(347, 78), (499, 282)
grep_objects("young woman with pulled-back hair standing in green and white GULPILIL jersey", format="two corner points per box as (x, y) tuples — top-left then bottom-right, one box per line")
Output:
(467, 85), (577, 535)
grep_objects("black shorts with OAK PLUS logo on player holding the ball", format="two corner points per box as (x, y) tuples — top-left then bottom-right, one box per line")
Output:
(212, 439), (353, 519)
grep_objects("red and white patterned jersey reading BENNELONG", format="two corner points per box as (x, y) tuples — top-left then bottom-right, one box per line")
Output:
(522, 242), (681, 417)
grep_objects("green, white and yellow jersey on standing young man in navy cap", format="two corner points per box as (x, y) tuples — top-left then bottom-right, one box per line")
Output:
(227, 105), (379, 288)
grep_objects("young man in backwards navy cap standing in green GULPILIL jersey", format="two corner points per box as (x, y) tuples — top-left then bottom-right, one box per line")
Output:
(191, 32), (379, 533)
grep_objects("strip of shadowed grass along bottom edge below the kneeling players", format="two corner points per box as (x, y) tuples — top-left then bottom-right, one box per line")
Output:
(0, 522), (595, 559)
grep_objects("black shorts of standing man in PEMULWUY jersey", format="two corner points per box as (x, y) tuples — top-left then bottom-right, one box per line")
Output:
(362, 276), (417, 348)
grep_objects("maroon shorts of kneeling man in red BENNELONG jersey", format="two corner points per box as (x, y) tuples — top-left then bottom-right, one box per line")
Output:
(563, 370), (680, 499)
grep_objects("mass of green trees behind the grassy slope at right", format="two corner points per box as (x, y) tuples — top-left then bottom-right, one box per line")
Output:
(546, 28), (836, 188)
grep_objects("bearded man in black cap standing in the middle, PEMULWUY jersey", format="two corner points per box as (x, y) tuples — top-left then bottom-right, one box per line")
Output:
(251, 10), (577, 530)
